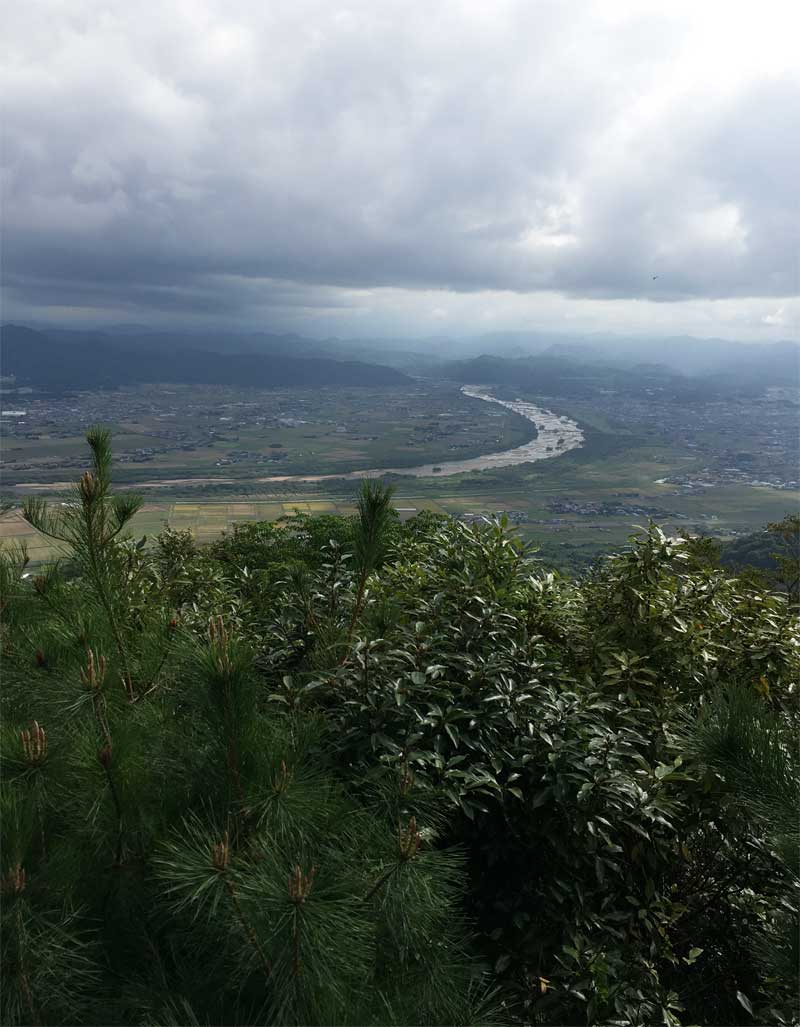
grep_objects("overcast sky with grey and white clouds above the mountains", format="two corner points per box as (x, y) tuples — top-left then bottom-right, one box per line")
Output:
(0, 0), (800, 341)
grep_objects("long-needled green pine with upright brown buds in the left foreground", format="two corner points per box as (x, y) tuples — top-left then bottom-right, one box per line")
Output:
(0, 430), (501, 1025)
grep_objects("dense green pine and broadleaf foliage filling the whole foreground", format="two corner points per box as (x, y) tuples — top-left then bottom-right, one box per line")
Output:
(0, 431), (800, 1024)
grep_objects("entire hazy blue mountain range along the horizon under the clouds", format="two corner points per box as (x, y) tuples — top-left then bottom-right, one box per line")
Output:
(0, 325), (800, 398)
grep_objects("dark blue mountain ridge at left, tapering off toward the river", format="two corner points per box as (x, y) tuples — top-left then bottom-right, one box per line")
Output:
(0, 325), (411, 388)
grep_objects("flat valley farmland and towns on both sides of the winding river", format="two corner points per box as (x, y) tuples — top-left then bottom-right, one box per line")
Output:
(0, 382), (800, 565)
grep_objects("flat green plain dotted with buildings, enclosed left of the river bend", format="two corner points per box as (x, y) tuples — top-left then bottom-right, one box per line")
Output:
(3, 382), (533, 488)
